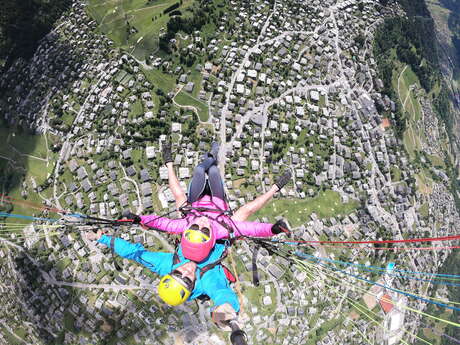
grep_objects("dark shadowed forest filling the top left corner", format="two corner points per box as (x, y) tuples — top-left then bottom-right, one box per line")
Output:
(0, 0), (71, 70)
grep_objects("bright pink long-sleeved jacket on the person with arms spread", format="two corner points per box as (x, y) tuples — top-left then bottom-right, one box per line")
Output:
(141, 195), (273, 239)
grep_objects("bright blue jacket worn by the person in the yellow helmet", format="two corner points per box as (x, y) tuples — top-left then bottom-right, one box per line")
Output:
(98, 235), (240, 312)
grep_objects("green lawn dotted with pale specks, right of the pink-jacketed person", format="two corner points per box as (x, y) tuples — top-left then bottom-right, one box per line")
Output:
(251, 190), (358, 227)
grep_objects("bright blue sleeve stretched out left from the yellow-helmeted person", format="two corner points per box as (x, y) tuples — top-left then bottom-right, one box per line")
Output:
(98, 235), (173, 275)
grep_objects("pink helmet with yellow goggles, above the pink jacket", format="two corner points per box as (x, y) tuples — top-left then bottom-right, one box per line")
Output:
(181, 224), (216, 262)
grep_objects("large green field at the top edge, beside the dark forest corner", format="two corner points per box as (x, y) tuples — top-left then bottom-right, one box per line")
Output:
(87, 0), (193, 60)
